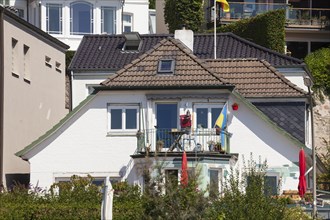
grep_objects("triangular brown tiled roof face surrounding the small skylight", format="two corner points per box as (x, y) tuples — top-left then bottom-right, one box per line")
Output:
(101, 38), (233, 89)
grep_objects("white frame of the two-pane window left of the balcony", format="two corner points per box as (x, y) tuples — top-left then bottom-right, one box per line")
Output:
(108, 103), (140, 135)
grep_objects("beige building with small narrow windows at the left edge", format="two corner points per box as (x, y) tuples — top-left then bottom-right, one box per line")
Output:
(0, 6), (69, 187)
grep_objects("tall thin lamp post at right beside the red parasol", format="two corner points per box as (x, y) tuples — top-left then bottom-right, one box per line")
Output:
(304, 76), (317, 219)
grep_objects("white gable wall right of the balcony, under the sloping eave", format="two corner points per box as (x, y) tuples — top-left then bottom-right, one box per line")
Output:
(228, 98), (300, 190)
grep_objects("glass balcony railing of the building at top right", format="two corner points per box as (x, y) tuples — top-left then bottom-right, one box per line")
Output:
(207, 2), (330, 28)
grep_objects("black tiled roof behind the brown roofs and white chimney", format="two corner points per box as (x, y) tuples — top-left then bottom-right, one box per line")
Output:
(69, 33), (302, 70)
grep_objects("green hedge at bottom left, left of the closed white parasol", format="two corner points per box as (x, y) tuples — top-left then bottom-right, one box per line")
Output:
(0, 176), (101, 219)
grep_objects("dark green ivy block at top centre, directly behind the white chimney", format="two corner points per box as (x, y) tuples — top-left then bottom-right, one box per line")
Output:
(164, 0), (204, 33)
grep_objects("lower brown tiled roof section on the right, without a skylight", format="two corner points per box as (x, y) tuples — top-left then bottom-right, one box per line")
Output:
(206, 59), (306, 98)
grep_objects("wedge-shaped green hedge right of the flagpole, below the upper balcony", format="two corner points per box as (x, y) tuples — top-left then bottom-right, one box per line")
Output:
(217, 9), (286, 53)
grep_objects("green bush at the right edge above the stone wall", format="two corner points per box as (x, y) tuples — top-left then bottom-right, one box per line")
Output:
(305, 48), (330, 96)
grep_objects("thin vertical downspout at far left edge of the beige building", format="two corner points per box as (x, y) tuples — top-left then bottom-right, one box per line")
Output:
(0, 8), (5, 186)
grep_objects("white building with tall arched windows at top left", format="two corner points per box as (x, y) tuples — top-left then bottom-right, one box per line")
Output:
(0, 0), (149, 50)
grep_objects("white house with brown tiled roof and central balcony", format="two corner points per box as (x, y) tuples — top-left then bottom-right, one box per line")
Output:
(17, 31), (318, 194)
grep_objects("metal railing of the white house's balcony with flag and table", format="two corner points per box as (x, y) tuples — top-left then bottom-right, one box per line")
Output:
(137, 128), (229, 153)
